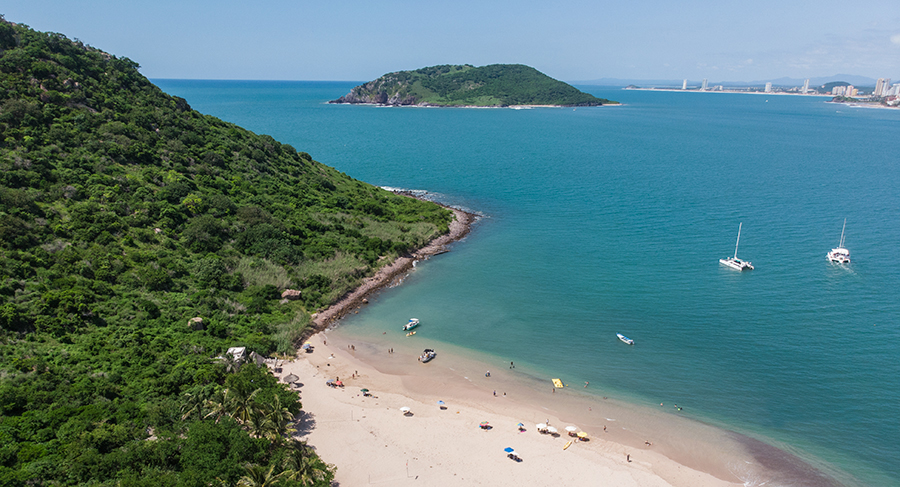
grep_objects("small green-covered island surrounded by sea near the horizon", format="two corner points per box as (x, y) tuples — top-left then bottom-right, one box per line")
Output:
(329, 64), (618, 107)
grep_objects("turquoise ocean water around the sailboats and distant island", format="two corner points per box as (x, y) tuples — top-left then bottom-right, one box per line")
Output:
(154, 80), (900, 486)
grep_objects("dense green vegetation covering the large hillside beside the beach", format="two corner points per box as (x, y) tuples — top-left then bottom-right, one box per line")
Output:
(0, 17), (451, 486)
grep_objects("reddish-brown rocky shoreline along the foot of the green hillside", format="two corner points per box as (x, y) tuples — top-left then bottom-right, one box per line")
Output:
(301, 191), (476, 341)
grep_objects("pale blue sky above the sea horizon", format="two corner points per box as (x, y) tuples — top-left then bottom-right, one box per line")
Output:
(0, 0), (900, 82)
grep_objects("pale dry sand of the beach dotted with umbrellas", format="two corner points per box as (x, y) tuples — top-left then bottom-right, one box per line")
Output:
(279, 334), (740, 487)
